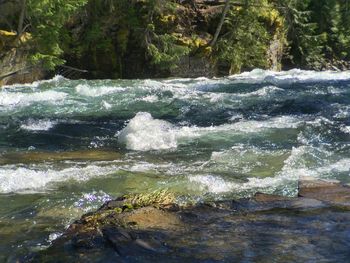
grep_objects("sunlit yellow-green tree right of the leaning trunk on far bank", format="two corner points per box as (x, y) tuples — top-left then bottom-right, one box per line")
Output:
(214, 1), (273, 73)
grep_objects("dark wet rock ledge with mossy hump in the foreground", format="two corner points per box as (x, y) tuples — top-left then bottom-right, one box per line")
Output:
(28, 177), (350, 262)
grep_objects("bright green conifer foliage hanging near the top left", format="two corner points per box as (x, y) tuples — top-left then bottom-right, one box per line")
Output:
(27, 0), (87, 69)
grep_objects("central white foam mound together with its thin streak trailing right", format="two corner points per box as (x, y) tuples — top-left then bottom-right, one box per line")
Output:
(118, 112), (301, 151)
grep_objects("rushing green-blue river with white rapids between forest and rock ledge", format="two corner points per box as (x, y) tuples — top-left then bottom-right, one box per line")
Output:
(0, 70), (350, 261)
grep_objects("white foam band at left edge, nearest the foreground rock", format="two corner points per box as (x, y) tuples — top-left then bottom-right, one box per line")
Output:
(0, 165), (118, 193)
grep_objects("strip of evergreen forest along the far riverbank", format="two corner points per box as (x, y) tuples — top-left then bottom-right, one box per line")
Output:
(0, 0), (350, 78)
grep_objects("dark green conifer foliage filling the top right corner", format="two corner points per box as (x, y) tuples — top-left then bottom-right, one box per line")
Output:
(277, 0), (350, 69)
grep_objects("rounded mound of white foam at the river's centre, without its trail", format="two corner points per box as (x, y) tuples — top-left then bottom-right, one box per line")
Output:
(118, 112), (177, 151)
